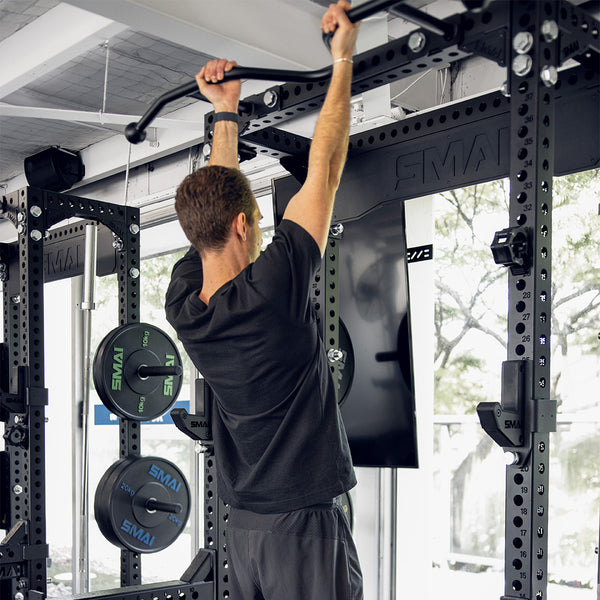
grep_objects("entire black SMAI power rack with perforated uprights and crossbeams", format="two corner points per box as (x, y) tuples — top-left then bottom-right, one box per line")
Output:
(0, 0), (600, 600)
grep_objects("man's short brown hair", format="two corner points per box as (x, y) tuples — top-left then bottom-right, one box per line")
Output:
(175, 165), (256, 254)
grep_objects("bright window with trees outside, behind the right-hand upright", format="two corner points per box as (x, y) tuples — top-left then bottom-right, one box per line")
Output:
(432, 171), (600, 600)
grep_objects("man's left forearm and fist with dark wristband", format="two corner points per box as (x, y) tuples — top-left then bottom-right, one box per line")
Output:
(196, 58), (241, 169)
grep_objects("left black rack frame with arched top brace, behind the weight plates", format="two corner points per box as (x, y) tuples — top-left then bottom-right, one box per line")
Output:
(0, 188), (141, 599)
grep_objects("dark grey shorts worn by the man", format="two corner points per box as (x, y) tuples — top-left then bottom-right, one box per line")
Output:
(227, 504), (363, 600)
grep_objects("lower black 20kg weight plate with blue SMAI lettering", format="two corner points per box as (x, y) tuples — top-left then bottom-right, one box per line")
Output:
(94, 456), (190, 553)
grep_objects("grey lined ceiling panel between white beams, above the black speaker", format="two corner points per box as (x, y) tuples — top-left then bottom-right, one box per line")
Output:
(0, 24), (213, 182)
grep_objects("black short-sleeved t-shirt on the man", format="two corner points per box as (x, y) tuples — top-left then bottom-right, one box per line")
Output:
(166, 220), (356, 513)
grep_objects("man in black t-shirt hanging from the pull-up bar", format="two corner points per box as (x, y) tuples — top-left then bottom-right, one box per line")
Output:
(166, 0), (363, 600)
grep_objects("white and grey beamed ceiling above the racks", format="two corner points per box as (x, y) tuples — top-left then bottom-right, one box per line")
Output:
(0, 0), (494, 192)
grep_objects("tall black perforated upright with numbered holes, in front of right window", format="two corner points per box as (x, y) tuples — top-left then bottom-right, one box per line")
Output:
(505, 0), (559, 600)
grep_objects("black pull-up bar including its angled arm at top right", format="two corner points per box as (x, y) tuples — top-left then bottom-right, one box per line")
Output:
(125, 0), (474, 144)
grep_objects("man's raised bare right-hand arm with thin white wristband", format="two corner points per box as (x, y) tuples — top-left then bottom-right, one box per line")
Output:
(283, 0), (358, 255)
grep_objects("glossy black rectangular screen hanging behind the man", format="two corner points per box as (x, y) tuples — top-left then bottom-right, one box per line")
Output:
(274, 176), (418, 467)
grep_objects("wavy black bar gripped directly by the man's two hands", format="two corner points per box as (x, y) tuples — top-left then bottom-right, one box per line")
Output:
(125, 0), (400, 144)
